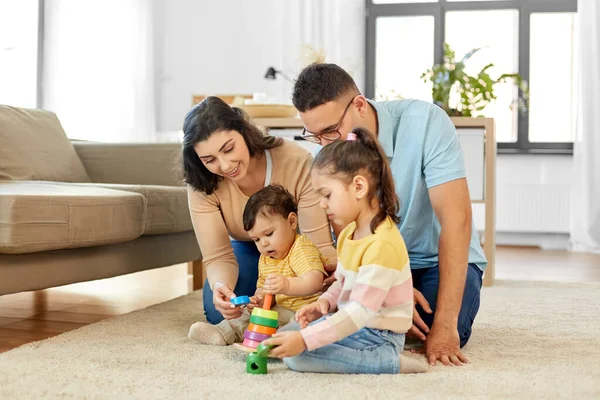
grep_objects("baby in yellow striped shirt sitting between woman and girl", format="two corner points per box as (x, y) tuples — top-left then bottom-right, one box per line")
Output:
(188, 185), (327, 346)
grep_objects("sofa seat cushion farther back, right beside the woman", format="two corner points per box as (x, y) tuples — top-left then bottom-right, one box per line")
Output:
(85, 183), (194, 235)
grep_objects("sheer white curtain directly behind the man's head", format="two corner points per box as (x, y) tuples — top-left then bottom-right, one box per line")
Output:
(281, 0), (366, 98)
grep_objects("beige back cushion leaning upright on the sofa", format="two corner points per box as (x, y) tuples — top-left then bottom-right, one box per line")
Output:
(0, 105), (90, 182)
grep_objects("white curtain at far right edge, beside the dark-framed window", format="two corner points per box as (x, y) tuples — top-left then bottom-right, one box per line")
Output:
(571, 0), (600, 252)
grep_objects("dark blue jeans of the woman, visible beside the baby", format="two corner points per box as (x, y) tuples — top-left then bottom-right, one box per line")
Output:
(202, 240), (260, 325)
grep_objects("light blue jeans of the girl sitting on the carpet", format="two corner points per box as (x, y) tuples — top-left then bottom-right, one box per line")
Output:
(281, 317), (404, 374)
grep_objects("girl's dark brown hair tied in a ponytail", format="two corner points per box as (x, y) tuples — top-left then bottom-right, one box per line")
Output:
(312, 128), (400, 233)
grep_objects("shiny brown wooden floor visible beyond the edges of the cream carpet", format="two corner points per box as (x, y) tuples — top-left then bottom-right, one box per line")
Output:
(0, 247), (600, 352)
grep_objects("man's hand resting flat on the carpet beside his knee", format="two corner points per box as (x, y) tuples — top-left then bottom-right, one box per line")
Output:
(425, 322), (469, 366)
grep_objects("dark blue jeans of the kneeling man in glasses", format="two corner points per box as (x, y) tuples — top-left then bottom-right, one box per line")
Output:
(412, 264), (483, 347)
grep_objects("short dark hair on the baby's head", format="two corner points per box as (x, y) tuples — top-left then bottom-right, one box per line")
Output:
(242, 185), (298, 231)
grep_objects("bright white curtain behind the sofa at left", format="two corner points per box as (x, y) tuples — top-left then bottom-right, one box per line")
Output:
(43, 0), (156, 142)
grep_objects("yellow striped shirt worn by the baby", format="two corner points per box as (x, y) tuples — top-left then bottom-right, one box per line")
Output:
(256, 235), (327, 311)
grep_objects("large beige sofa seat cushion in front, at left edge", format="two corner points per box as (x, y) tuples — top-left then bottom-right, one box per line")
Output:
(0, 181), (146, 254)
